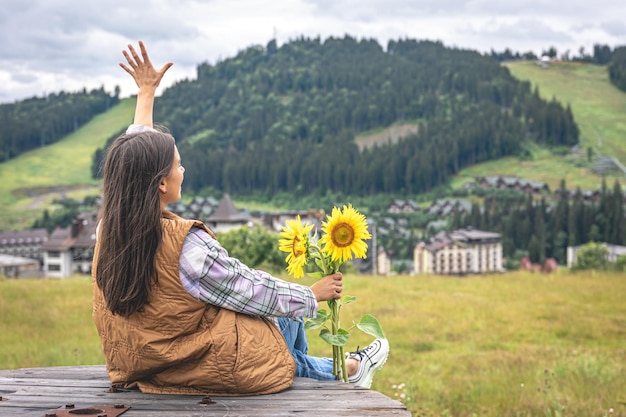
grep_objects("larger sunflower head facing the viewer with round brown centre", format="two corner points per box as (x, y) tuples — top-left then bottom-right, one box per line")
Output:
(320, 204), (372, 262)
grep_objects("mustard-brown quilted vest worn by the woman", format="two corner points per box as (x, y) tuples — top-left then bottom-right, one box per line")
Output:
(92, 213), (295, 396)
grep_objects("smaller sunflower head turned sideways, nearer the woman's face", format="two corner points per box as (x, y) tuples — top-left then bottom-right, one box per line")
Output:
(278, 216), (313, 278)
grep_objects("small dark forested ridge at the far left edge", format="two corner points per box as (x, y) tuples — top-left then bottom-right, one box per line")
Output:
(0, 88), (119, 161)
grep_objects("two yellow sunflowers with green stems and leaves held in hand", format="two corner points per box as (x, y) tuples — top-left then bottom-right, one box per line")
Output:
(279, 204), (384, 382)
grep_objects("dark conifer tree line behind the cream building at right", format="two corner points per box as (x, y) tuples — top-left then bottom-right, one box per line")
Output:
(452, 180), (626, 264)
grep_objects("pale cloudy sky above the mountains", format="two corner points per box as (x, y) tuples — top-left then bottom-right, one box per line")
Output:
(0, 0), (626, 103)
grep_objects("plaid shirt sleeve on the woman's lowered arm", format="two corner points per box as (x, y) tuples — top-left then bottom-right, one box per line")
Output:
(180, 227), (318, 319)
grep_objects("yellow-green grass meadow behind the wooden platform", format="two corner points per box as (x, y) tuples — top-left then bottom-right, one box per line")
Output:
(0, 271), (626, 417)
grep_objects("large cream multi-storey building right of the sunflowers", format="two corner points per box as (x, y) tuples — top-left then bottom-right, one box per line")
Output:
(413, 228), (504, 275)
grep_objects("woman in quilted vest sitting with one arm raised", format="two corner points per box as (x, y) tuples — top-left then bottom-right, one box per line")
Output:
(93, 42), (389, 395)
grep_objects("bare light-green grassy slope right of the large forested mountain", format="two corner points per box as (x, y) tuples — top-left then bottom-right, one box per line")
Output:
(452, 61), (626, 190)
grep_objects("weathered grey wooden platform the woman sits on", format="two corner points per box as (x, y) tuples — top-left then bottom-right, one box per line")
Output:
(0, 365), (411, 417)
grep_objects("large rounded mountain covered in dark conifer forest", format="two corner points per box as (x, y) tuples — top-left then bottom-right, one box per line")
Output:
(97, 36), (578, 195)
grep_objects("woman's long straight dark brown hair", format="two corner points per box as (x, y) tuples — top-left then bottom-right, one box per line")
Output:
(95, 132), (175, 317)
